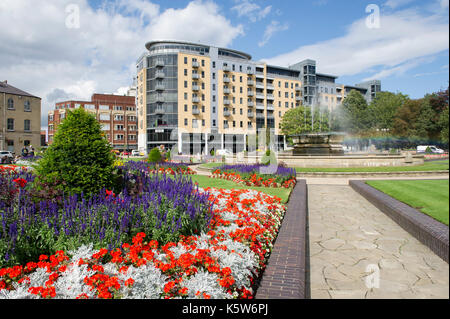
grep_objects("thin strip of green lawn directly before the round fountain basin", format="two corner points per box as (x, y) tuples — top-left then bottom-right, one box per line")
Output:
(295, 160), (449, 173)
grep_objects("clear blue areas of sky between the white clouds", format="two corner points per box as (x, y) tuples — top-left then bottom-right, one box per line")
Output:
(89, 0), (449, 98)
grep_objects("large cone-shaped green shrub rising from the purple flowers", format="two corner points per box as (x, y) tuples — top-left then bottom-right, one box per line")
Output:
(36, 109), (115, 195)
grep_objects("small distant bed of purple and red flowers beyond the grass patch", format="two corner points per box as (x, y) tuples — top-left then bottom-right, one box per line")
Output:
(211, 164), (297, 188)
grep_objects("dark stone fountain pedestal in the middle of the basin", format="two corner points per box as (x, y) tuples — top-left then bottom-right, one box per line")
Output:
(291, 133), (344, 156)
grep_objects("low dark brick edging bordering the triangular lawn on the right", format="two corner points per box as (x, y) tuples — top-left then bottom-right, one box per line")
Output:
(349, 180), (449, 263)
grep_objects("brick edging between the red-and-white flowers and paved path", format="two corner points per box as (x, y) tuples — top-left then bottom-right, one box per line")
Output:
(255, 180), (308, 299)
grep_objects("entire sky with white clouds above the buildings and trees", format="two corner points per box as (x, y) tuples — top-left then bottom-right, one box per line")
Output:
(0, 0), (449, 128)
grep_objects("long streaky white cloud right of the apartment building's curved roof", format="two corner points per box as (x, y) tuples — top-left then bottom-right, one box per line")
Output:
(266, 10), (449, 76)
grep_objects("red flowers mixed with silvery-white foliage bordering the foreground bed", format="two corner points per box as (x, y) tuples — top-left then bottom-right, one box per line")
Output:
(0, 189), (285, 299)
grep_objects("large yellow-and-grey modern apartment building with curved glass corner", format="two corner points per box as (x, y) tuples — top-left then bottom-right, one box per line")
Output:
(136, 41), (380, 154)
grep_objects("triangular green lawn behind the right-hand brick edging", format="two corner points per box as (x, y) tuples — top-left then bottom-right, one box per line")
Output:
(366, 180), (449, 225)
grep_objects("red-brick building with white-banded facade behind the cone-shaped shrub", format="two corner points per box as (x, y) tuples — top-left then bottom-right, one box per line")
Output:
(48, 94), (137, 151)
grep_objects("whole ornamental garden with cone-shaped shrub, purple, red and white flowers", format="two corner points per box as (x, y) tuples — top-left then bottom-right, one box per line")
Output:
(0, 109), (296, 299)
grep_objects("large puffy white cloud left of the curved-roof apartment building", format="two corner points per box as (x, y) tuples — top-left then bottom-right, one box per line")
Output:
(0, 0), (243, 126)
